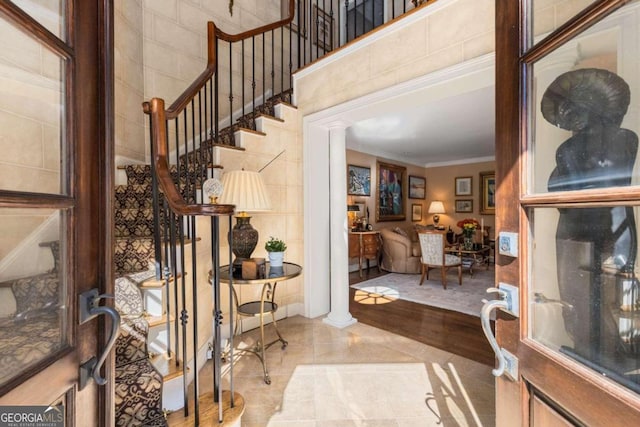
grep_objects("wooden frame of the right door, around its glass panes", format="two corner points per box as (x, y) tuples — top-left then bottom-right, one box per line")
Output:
(496, 0), (640, 426)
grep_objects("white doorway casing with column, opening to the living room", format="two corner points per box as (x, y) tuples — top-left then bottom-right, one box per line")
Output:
(294, 53), (495, 327)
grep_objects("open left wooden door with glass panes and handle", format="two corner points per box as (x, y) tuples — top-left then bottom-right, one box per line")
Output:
(0, 0), (113, 426)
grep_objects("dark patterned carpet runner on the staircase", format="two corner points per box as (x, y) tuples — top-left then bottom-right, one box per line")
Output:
(114, 90), (292, 427)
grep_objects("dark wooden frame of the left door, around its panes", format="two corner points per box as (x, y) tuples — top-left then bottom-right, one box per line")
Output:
(0, 0), (115, 426)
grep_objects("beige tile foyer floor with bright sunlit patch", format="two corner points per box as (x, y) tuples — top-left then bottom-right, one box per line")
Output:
(190, 316), (495, 427)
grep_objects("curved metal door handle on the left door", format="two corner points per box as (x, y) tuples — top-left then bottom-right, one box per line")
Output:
(78, 289), (120, 390)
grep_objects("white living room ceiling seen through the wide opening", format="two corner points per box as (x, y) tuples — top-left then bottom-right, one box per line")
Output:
(346, 85), (495, 167)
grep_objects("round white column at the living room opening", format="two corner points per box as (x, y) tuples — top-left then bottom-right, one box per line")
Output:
(323, 123), (357, 328)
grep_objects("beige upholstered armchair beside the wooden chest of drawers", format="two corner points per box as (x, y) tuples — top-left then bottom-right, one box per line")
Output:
(380, 228), (420, 274)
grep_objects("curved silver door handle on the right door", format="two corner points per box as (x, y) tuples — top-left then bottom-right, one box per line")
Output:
(480, 283), (518, 380)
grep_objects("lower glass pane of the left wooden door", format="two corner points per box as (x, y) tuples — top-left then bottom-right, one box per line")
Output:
(0, 208), (69, 387)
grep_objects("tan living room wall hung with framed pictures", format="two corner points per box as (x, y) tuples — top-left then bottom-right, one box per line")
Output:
(347, 150), (496, 236)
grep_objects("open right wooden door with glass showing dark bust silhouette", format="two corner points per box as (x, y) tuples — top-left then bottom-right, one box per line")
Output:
(496, 0), (640, 426)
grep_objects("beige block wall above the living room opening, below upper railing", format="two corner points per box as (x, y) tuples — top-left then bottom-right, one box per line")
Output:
(295, 0), (495, 117)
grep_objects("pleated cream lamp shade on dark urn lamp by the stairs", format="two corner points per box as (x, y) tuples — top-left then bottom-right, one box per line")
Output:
(218, 170), (271, 212)
